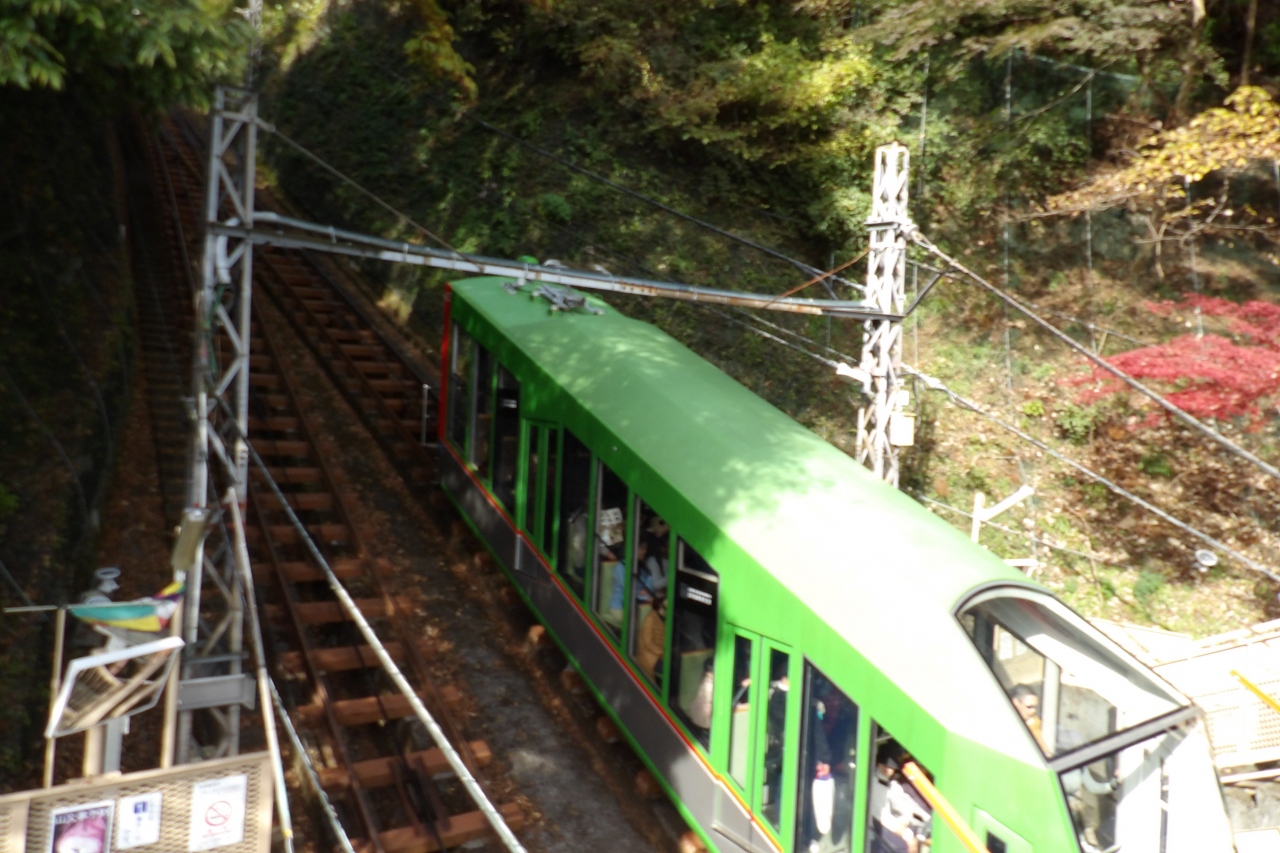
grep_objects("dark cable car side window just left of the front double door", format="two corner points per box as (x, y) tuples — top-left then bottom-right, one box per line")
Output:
(667, 539), (719, 748)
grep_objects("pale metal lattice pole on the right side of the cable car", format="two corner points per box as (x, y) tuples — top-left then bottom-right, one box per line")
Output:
(858, 142), (915, 487)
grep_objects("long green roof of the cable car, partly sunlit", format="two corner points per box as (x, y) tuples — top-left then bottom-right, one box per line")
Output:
(453, 278), (1041, 763)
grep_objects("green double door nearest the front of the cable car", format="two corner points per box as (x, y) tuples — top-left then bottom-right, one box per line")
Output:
(714, 626), (800, 853)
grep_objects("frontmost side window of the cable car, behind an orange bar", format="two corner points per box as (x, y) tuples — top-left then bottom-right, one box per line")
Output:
(867, 724), (933, 853)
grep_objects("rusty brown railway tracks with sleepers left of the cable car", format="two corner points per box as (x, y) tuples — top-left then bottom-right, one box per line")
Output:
(138, 116), (522, 853)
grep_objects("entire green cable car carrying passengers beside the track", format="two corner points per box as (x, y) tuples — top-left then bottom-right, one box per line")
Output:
(439, 278), (1233, 853)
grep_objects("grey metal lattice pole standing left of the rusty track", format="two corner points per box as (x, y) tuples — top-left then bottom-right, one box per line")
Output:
(174, 87), (258, 763)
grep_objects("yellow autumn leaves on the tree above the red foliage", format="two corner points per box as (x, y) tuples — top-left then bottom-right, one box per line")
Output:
(1046, 86), (1280, 278)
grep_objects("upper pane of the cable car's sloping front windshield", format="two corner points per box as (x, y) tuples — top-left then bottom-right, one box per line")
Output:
(960, 588), (1183, 756)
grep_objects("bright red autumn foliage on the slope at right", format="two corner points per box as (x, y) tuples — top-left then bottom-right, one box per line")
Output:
(1064, 295), (1280, 425)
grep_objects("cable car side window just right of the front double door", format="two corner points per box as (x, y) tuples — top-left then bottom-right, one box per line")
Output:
(795, 661), (858, 853)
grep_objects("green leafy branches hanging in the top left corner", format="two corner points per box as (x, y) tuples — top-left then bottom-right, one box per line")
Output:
(0, 0), (248, 109)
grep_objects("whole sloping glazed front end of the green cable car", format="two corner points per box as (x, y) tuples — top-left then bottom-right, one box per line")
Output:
(960, 588), (1231, 853)
